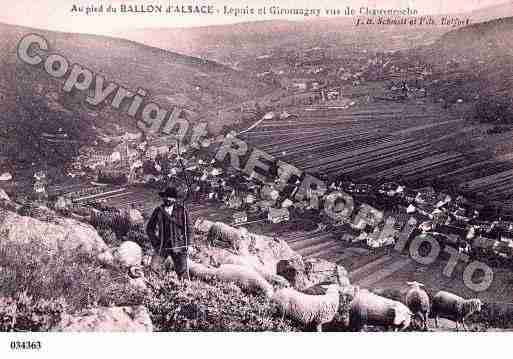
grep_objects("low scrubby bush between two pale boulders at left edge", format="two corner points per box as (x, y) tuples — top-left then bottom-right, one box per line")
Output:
(0, 238), (148, 326)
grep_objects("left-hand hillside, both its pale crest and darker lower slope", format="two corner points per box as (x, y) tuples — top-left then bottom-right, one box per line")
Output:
(0, 24), (271, 170)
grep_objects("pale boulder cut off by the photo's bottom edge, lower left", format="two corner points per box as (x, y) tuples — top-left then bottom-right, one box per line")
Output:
(52, 306), (153, 332)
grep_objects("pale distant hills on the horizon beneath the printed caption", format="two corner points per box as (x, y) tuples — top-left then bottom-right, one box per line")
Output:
(115, 3), (513, 67)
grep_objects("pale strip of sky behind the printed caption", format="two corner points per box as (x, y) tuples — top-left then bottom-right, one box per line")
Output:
(0, 0), (506, 34)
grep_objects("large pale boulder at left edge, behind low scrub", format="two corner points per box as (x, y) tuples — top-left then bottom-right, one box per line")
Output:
(0, 212), (111, 260)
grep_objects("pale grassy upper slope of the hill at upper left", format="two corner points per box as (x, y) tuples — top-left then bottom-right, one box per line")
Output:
(0, 24), (272, 111)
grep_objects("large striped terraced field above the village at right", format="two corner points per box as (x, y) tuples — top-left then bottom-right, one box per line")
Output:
(241, 91), (513, 207)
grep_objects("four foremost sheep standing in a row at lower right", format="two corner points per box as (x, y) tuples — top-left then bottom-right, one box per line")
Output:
(272, 282), (482, 331)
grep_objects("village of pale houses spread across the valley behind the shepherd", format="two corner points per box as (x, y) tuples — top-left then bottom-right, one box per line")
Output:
(9, 107), (513, 276)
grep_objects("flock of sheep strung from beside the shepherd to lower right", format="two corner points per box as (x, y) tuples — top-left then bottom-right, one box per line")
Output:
(189, 253), (482, 331)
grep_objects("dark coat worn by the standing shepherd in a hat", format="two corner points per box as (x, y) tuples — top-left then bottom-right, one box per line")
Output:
(146, 203), (192, 255)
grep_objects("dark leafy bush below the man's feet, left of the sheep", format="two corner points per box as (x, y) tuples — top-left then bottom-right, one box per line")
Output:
(142, 274), (299, 331)
